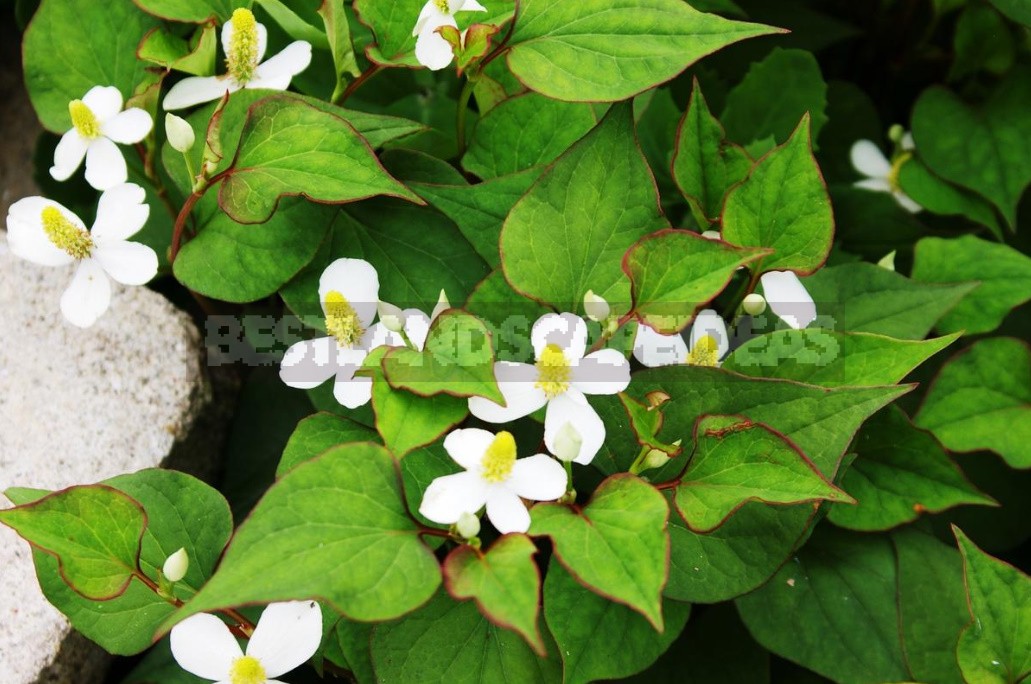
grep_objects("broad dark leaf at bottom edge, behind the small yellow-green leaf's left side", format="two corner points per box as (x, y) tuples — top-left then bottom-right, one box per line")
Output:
(372, 591), (562, 684)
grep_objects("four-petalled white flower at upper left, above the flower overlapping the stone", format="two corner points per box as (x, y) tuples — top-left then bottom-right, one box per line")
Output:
(51, 86), (154, 190)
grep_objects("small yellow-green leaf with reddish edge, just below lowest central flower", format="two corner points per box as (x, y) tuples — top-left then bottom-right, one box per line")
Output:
(443, 534), (547, 657)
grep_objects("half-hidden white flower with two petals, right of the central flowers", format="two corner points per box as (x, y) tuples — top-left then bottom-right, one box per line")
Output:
(634, 308), (730, 368)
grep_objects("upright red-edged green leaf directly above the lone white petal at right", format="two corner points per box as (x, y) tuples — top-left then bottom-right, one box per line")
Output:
(723, 116), (834, 274)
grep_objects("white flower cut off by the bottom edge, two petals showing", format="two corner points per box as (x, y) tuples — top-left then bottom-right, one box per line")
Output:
(170, 600), (323, 684)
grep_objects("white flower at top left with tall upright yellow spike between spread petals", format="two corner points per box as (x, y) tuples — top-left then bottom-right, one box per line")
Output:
(161, 7), (311, 109)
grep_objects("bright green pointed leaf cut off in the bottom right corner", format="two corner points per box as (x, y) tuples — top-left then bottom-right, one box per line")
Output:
(953, 526), (1031, 684)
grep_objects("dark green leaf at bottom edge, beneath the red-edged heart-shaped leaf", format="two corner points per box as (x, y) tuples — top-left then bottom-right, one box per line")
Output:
(544, 561), (691, 684)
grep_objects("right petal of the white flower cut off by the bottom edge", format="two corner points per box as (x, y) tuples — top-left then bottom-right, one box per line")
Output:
(247, 600), (322, 677)
